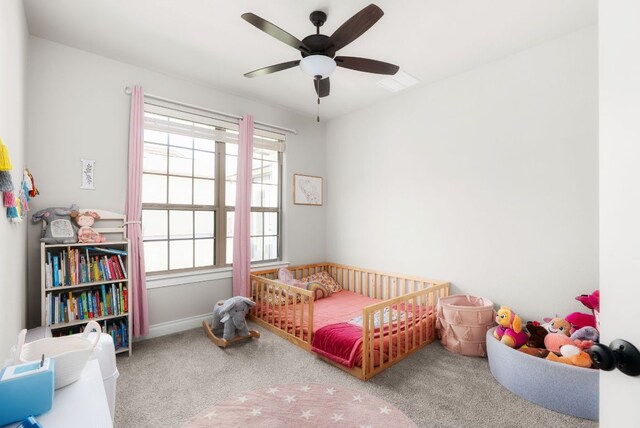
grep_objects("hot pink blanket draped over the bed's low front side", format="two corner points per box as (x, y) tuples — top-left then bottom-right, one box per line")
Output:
(311, 322), (362, 368)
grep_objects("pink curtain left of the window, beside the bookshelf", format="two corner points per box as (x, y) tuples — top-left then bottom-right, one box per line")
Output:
(125, 86), (149, 337)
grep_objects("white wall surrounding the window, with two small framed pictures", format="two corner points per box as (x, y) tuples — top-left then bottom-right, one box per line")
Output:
(29, 37), (325, 327)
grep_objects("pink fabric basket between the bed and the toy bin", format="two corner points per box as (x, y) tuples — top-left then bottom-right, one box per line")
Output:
(436, 294), (495, 357)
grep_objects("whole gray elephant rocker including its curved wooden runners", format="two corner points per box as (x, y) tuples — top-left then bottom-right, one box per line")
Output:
(202, 296), (260, 348)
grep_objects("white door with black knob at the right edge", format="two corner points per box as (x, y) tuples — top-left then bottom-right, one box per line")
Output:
(599, 0), (640, 427)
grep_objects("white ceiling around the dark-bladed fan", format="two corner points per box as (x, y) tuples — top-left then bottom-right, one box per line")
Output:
(24, 0), (597, 120)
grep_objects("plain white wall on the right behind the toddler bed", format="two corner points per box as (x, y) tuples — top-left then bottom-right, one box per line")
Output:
(326, 28), (598, 319)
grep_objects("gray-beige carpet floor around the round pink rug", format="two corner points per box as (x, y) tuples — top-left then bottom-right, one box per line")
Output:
(115, 325), (597, 428)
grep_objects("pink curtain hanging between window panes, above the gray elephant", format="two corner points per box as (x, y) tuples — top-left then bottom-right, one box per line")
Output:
(233, 114), (253, 296)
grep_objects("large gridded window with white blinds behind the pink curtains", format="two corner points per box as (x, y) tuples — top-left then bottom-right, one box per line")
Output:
(142, 103), (284, 273)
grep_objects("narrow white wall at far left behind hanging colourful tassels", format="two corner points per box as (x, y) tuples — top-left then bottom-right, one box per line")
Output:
(0, 0), (29, 366)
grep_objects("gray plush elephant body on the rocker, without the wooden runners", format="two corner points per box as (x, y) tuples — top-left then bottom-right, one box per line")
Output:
(211, 296), (255, 340)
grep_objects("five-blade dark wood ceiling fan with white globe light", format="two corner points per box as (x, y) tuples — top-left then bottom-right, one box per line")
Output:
(242, 4), (399, 119)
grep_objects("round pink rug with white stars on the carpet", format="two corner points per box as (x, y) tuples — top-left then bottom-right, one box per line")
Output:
(183, 384), (417, 428)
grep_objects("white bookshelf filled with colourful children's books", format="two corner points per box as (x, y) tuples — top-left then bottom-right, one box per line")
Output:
(40, 209), (131, 355)
